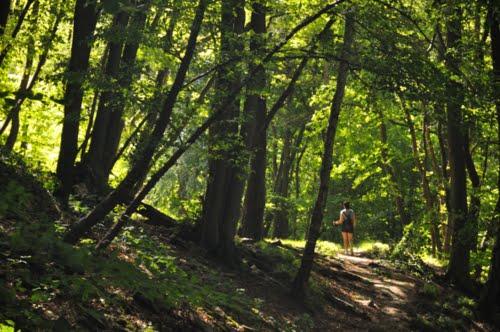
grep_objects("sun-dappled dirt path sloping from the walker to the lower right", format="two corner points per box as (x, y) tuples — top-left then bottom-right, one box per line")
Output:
(315, 253), (490, 331)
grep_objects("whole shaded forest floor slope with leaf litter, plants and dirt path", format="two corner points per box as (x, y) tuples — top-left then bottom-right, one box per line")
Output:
(0, 160), (494, 331)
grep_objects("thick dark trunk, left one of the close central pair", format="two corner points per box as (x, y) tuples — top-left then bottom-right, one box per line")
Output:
(201, 0), (245, 264)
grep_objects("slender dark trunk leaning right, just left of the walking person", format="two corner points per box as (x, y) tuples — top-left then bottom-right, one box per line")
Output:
(292, 12), (354, 298)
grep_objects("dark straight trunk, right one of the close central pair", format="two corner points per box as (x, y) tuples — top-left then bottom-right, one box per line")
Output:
(240, 1), (267, 240)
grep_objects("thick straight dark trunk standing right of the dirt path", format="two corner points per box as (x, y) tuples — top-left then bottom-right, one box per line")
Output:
(445, 0), (471, 291)
